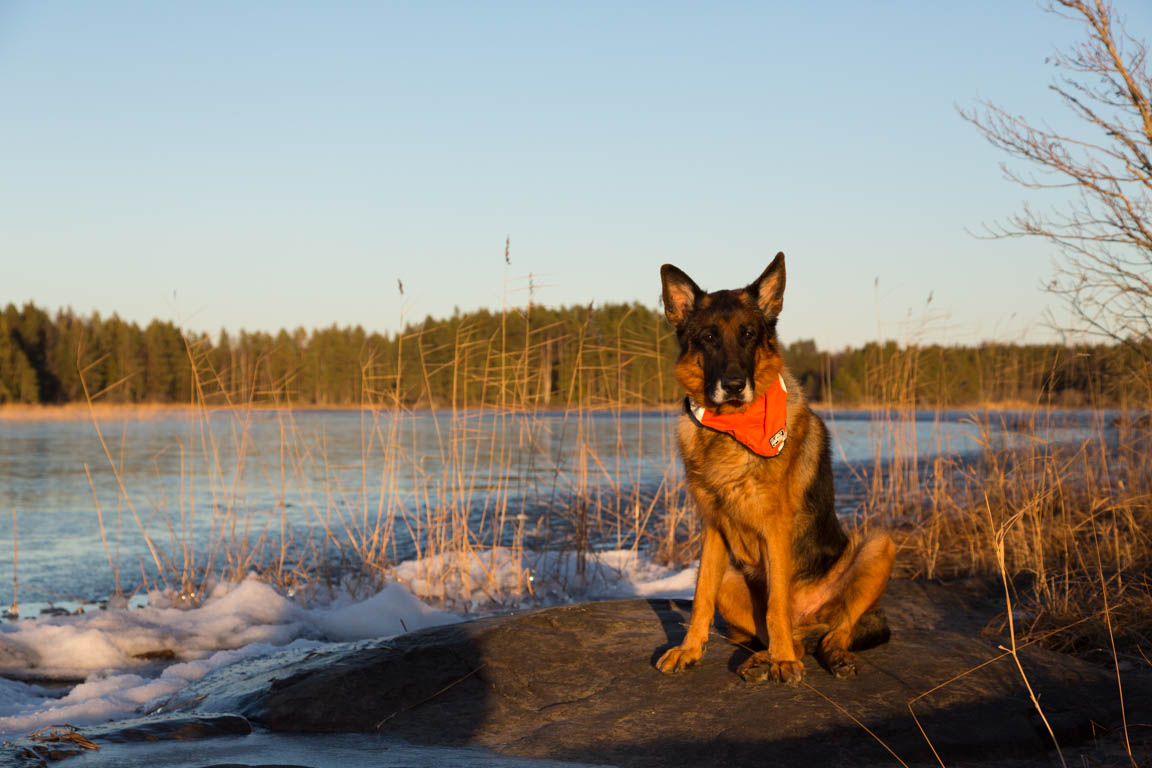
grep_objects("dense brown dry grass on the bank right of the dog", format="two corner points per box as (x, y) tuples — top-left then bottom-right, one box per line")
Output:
(870, 415), (1152, 666)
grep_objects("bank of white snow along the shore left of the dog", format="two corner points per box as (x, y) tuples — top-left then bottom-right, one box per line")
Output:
(0, 549), (696, 739)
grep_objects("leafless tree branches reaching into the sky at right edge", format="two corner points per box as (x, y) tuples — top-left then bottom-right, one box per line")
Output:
(960, 0), (1152, 360)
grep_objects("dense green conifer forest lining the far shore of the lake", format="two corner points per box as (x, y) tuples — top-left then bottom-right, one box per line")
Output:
(0, 304), (1152, 408)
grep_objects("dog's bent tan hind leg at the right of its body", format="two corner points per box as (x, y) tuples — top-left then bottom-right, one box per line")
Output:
(817, 533), (896, 677)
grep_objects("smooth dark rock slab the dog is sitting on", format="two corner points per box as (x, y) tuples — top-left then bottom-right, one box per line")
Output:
(172, 581), (1152, 768)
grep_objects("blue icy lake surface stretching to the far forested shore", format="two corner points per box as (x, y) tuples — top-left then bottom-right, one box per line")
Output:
(0, 410), (1106, 615)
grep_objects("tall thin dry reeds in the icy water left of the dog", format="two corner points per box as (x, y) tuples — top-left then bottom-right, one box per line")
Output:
(74, 299), (698, 603)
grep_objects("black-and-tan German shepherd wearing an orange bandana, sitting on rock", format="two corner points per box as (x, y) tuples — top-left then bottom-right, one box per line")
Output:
(657, 253), (895, 684)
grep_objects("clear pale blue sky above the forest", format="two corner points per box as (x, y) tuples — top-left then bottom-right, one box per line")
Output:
(0, 0), (1152, 348)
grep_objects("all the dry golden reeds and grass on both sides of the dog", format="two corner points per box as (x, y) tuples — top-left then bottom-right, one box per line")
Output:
(63, 311), (1152, 664)
